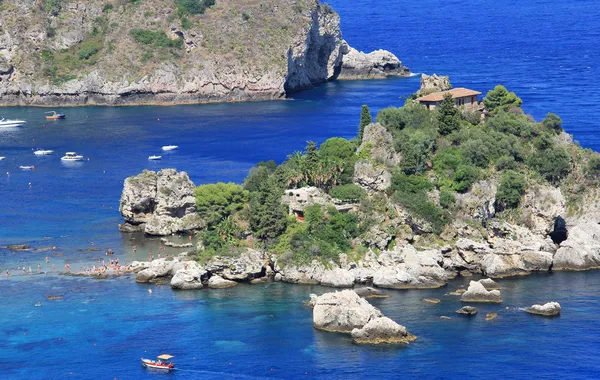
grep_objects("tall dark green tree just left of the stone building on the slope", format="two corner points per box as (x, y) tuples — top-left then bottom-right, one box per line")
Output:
(248, 178), (287, 242)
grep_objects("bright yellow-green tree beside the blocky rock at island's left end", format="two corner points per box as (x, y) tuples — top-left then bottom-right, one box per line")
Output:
(194, 182), (248, 228)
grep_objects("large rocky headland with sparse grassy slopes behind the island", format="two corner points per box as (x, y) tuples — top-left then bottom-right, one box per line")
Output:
(0, 0), (407, 105)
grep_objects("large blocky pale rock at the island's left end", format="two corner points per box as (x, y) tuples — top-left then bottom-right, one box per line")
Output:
(119, 169), (203, 235)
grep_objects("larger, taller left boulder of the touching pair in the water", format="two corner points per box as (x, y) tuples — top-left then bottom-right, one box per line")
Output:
(311, 290), (382, 333)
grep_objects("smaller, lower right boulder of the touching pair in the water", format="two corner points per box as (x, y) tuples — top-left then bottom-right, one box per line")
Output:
(352, 317), (417, 344)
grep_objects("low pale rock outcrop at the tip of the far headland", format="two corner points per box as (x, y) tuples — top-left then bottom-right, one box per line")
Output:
(338, 47), (410, 79)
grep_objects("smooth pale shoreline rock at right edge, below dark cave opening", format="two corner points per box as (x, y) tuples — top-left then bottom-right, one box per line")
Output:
(552, 221), (600, 270)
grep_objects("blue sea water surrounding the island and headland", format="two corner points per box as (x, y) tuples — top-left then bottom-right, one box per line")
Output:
(0, 0), (600, 379)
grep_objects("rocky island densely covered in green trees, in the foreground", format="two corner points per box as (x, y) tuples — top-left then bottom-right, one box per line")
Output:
(116, 78), (600, 290)
